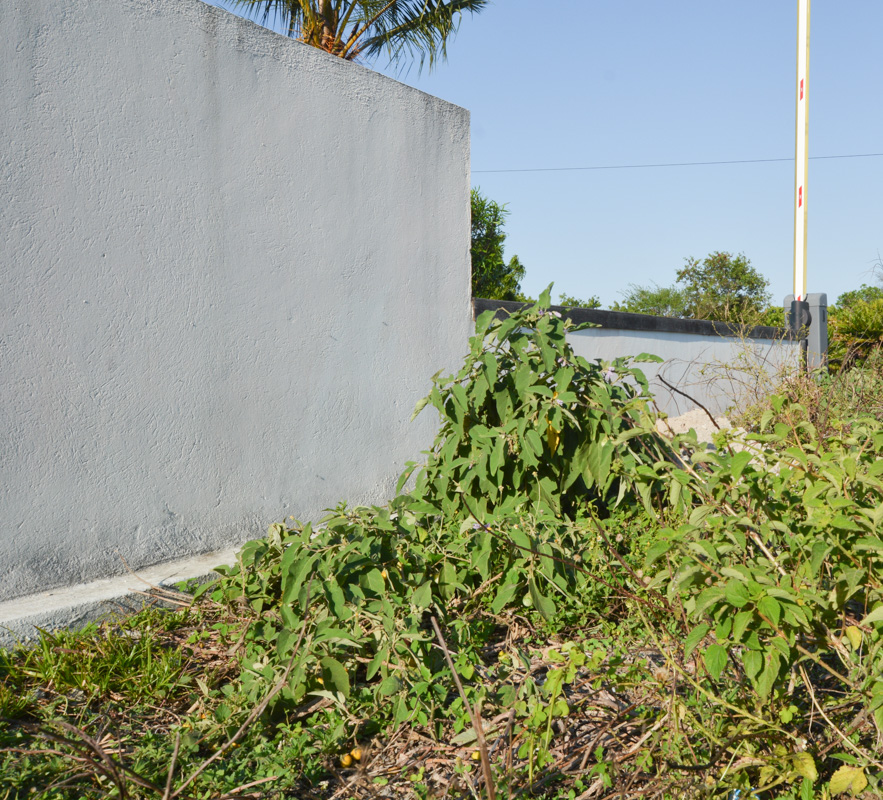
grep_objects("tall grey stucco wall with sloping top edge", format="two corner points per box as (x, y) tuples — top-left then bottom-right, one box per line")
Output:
(0, 0), (470, 600)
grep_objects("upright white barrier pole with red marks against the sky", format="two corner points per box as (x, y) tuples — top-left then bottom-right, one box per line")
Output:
(794, 0), (810, 300)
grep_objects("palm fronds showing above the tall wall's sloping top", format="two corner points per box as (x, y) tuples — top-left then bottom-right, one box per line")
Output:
(221, 0), (488, 68)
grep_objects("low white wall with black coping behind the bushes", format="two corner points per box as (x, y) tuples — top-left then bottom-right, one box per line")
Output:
(474, 300), (799, 416)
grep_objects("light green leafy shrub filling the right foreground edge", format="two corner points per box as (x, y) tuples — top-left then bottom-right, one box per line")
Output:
(646, 398), (883, 794)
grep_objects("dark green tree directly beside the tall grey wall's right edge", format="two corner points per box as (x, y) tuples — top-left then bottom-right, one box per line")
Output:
(471, 189), (525, 300)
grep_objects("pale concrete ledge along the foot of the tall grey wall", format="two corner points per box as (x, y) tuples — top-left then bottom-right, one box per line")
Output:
(0, 547), (241, 649)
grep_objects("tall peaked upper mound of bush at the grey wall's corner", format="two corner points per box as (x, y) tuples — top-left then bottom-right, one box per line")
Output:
(408, 289), (673, 520)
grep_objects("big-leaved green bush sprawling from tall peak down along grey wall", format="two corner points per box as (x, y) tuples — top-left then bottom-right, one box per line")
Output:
(213, 290), (680, 722)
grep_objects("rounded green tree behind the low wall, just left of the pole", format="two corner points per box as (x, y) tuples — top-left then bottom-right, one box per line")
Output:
(614, 250), (770, 324)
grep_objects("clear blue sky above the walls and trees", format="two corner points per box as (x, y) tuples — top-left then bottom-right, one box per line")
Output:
(204, 0), (883, 306)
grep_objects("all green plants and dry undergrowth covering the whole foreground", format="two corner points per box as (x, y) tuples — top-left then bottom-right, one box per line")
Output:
(0, 291), (883, 800)
